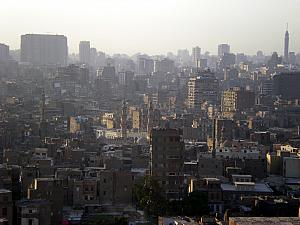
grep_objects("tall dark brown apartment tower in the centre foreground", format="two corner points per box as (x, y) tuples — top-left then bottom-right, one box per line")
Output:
(150, 128), (184, 200)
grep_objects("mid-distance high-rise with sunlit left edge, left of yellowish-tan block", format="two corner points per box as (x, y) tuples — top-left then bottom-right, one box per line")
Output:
(187, 71), (219, 111)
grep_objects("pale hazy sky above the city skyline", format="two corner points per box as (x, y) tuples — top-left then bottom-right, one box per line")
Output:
(0, 0), (300, 54)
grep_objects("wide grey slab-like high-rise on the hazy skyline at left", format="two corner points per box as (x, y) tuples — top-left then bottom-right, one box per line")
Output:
(21, 34), (68, 66)
